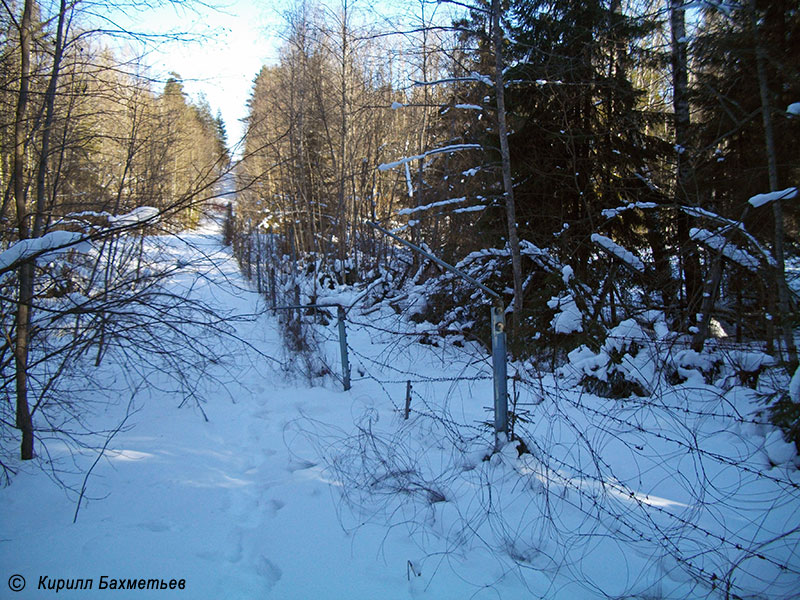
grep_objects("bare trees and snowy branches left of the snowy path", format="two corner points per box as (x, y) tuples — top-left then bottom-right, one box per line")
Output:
(0, 0), (230, 462)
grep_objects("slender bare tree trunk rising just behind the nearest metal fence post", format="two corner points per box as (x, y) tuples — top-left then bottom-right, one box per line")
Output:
(492, 0), (522, 316)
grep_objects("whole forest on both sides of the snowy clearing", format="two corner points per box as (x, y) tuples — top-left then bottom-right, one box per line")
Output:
(0, 0), (800, 456)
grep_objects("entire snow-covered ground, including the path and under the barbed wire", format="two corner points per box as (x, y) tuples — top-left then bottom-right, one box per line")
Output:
(0, 225), (800, 600)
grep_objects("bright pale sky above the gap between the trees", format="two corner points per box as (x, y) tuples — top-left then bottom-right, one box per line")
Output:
(108, 0), (282, 150)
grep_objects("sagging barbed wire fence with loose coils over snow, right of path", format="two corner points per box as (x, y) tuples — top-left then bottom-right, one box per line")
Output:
(228, 216), (800, 600)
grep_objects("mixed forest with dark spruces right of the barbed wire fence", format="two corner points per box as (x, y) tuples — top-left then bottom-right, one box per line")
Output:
(234, 0), (800, 408)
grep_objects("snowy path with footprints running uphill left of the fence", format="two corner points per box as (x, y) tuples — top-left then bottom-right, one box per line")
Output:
(0, 221), (520, 600)
